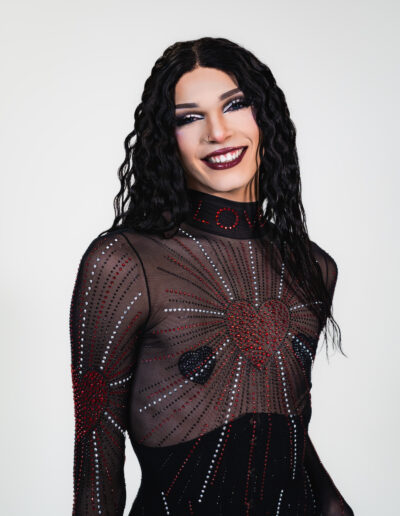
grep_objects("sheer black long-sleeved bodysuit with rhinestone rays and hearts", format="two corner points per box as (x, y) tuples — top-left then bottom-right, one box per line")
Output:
(70, 189), (348, 516)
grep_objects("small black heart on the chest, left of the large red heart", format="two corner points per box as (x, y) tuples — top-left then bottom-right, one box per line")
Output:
(178, 346), (216, 385)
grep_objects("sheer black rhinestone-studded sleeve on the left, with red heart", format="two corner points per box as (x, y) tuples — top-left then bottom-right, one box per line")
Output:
(70, 233), (149, 516)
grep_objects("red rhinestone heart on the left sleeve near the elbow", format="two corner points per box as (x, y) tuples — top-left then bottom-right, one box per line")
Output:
(72, 371), (108, 440)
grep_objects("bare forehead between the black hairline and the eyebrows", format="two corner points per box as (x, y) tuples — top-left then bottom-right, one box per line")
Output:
(175, 67), (237, 104)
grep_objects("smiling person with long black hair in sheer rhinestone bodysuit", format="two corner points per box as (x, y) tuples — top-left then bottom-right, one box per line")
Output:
(70, 38), (353, 516)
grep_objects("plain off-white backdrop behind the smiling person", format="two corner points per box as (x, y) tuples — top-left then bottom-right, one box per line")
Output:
(0, 0), (400, 516)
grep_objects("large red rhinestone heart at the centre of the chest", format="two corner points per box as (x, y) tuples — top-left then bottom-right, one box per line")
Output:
(226, 299), (290, 369)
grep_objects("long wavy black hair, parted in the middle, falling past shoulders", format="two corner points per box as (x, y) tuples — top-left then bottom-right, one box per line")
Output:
(101, 37), (344, 354)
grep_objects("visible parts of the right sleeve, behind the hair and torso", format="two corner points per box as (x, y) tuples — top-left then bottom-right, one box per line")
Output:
(304, 242), (354, 516)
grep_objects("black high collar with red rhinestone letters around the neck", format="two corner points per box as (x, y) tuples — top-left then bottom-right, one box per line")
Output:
(185, 188), (267, 238)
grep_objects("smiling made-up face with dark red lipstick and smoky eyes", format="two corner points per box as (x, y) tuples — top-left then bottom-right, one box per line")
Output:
(175, 67), (260, 201)
